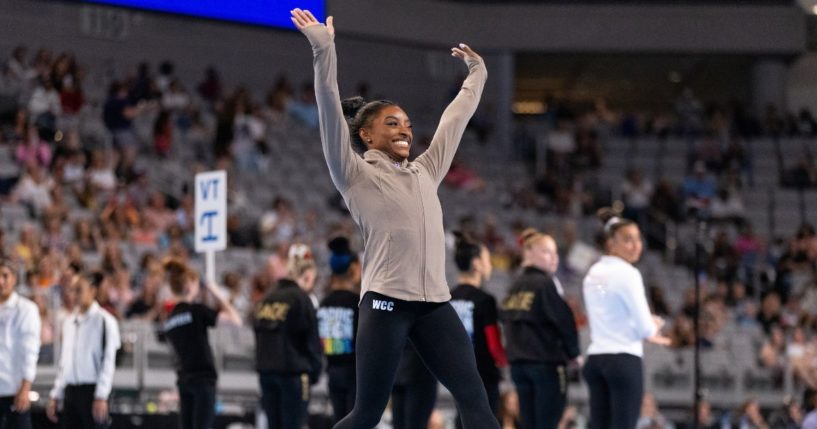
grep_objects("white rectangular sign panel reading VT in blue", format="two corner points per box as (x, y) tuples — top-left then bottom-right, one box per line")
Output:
(196, 171), (227, 252)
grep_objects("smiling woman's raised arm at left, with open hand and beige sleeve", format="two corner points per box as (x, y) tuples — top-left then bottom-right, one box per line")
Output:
(291, 9), (363, 192)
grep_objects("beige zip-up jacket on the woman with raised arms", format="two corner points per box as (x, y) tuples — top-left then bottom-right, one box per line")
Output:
(304, 25), (488, 302)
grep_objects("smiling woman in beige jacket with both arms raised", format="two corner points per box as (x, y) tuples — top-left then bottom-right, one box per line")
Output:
(292, 9), (498, 429)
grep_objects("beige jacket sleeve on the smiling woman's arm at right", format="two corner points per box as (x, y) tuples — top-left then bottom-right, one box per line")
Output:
(415, 58), (488, 185)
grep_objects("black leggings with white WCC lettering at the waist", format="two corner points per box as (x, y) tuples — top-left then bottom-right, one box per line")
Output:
(335, 292), (499, 429)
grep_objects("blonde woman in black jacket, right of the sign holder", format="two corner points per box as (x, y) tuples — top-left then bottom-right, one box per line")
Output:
(253, 244), (323, 429)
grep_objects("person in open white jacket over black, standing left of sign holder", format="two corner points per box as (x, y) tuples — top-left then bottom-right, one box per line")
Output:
(46, 272), (121, 429)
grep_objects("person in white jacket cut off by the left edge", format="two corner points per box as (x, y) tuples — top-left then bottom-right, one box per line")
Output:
(0, 259), (41, 429)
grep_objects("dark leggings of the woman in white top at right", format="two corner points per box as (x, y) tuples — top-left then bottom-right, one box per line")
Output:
(582, 353), (644, 429)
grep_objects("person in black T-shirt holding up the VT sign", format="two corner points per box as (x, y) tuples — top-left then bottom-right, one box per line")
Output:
(163, 259), (241, 429)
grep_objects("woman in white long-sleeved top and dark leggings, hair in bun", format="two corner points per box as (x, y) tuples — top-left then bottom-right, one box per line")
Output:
(582, 208), (670, 429)
